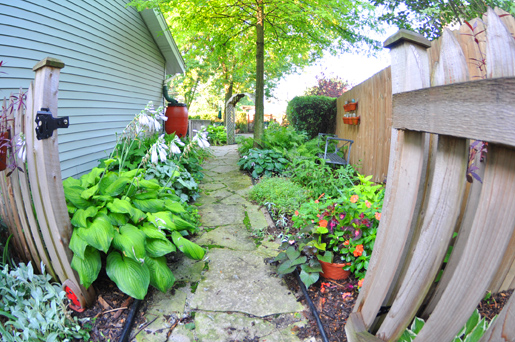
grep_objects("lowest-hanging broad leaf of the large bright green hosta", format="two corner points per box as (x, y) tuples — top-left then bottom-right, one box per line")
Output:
(106, 251), (150, 299)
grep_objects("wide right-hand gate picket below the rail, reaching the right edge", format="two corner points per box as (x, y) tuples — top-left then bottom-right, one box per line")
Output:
(416, 144), (515, 341)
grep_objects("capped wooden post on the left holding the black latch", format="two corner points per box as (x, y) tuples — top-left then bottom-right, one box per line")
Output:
(26, 57), (94, 307)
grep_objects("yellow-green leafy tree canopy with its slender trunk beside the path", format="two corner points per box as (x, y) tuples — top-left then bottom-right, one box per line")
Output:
(129, 0), (379, 144)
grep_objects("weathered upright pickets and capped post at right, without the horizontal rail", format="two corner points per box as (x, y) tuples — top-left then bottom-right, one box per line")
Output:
(346, 9), (515, 342)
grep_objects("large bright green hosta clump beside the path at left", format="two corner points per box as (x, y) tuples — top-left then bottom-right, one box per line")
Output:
(63, 166), (204, 299)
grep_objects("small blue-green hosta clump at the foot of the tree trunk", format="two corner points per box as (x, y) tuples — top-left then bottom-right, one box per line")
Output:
(238, 149), (288, 179)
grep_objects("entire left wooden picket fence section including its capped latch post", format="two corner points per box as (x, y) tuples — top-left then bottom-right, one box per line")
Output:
(0, 58), (93, 306)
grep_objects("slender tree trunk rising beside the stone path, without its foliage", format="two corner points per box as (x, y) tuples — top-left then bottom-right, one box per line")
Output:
(254, 0), (265, 147)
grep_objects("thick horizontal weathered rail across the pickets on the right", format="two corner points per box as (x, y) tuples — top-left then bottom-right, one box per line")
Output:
(393, 77), (515, 146)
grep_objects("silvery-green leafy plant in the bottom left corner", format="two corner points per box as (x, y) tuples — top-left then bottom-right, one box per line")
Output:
(0, 262), (89, 342)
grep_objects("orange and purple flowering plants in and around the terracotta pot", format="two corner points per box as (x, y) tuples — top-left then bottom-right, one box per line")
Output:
(275, 175), (384, 287)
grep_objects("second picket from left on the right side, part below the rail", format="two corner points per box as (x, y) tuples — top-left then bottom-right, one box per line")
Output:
(377, 136), (468, 341)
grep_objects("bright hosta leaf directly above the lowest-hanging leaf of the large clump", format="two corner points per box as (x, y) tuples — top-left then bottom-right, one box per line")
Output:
(113, 224), (147, 263)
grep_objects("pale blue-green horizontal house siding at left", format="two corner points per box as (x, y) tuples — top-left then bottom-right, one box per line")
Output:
(0, 0), (165, 179)
